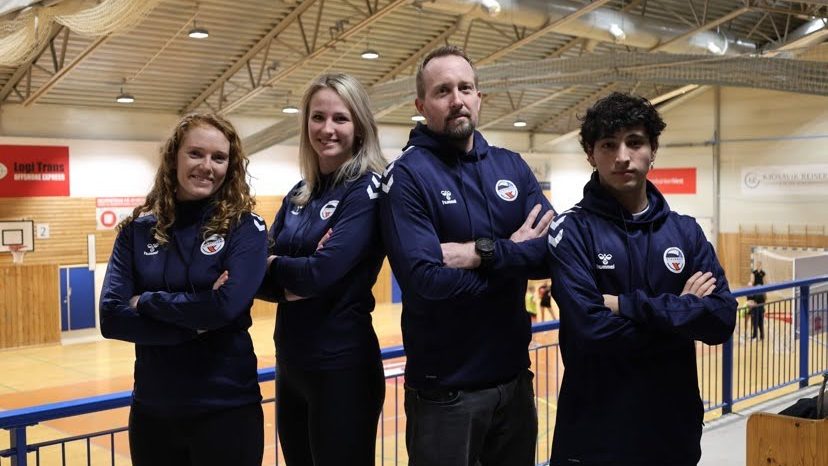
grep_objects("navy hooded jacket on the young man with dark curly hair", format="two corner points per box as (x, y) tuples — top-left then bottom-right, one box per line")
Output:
(549, 174), (736, 466)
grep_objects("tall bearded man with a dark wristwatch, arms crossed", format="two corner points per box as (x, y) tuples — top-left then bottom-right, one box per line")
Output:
(380, 46), (554, 466)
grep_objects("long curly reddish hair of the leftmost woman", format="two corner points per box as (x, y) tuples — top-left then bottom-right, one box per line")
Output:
(119, 113), (256, 246)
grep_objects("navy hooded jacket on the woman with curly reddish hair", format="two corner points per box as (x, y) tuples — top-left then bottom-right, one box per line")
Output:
(100, 201), (267, 417)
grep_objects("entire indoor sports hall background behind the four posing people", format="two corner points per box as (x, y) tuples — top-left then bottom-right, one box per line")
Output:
(0, 0), (828, 466)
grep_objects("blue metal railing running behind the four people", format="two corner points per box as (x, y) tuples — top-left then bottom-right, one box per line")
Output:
(0, 275), (828, 466)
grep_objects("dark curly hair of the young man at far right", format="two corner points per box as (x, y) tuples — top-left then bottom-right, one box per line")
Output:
(578, 92), (667, 154)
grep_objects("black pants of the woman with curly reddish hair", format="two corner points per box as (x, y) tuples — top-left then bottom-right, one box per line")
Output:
(129, 403), (264, 466)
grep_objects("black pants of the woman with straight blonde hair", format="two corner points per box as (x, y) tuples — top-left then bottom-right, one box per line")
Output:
(276, 356), (385, 466)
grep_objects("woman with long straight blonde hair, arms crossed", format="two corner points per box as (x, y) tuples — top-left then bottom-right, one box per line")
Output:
(263, 74), (386, 466)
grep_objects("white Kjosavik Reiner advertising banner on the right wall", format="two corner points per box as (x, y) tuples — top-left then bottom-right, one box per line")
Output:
(742, 164), (828, 196)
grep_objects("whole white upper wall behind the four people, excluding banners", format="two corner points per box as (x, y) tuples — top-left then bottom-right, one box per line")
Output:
(0, 89), (828, 237)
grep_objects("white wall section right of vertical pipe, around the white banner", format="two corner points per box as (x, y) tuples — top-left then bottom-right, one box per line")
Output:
(721, 89), (828, 232)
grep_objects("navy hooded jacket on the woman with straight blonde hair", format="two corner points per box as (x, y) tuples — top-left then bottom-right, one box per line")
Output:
(263, 172), (385, 370)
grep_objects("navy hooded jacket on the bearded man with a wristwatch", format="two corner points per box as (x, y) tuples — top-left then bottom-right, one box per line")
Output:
(380, 124), (552, 389)
